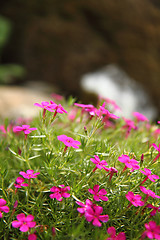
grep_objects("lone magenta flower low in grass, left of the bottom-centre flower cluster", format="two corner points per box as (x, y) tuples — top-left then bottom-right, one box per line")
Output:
(49, 184), (70, 202)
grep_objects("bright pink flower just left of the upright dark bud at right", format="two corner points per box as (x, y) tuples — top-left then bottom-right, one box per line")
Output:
(118, 155), (140, 171)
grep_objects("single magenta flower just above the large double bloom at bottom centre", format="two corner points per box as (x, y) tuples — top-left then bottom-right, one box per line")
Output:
(88, 185), (108, 201)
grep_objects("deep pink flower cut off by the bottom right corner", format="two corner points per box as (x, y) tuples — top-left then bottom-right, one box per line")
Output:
(142, 221), (160, 239)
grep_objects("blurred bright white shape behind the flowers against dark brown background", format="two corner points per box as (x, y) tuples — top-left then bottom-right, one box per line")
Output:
(81, 65), (157, 120)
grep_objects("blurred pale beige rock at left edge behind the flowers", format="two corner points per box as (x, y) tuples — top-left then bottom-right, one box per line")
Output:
(0, 86), (53, 119)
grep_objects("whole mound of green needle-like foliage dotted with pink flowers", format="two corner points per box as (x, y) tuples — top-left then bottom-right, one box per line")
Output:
(0, 94), (160, 240)
